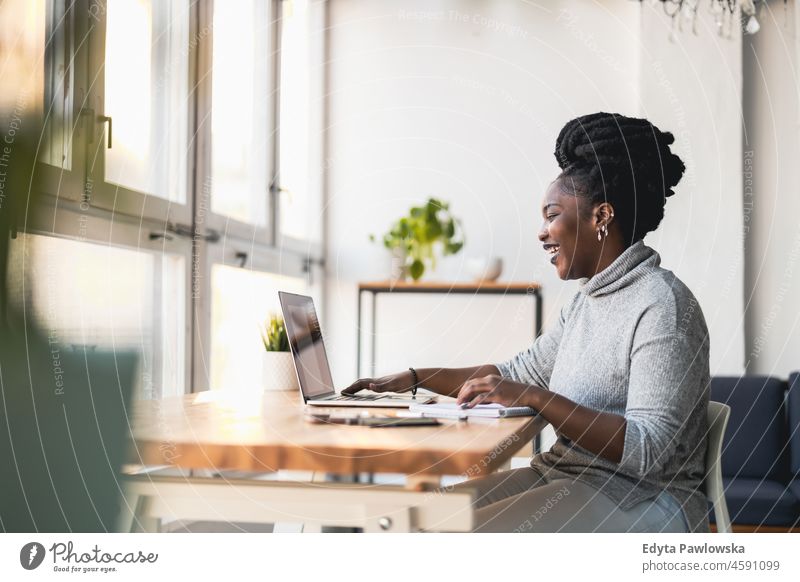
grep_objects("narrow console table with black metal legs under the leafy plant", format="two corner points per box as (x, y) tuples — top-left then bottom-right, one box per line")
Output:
(356, 281), (542, 377)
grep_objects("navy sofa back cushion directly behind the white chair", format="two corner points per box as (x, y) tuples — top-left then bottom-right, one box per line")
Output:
(711, 376), (789, 481)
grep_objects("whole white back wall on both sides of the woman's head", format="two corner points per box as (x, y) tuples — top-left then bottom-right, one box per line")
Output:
(325, 0), (760, 385)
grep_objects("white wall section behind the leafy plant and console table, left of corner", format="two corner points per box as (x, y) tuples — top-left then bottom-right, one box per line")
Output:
(324, 0), (640, 385)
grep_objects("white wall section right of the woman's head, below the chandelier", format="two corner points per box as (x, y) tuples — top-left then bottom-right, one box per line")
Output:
(639, 2), (748, 374)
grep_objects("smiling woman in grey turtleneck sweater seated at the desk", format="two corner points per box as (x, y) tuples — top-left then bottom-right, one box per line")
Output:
(346, 113), (709, 532)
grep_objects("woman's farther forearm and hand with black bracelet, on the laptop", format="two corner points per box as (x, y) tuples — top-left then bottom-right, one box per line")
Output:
(342, 364), (500, 397)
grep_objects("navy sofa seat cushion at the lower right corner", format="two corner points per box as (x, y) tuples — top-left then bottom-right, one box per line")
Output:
(712, 477), (800, 526)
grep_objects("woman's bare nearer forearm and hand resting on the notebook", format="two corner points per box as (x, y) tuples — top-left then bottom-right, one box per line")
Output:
(458, 375), (626, 463)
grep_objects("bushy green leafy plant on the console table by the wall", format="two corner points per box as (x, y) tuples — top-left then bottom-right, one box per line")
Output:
(370, 198), (464, 281)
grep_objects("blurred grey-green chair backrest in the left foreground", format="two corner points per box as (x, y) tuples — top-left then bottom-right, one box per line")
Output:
(0, 329), (140, 532)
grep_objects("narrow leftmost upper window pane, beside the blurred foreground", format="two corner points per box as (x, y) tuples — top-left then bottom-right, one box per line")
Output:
(39, 0), (74, 170)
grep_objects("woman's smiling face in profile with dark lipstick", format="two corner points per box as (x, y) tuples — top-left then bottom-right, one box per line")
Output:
(539, 178), (602, 280)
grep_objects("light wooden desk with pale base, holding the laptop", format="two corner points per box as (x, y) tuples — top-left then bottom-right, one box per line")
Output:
(122, 391), (546, 531)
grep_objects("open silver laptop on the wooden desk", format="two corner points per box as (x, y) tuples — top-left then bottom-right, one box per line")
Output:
(278, 291), (433, 408)
